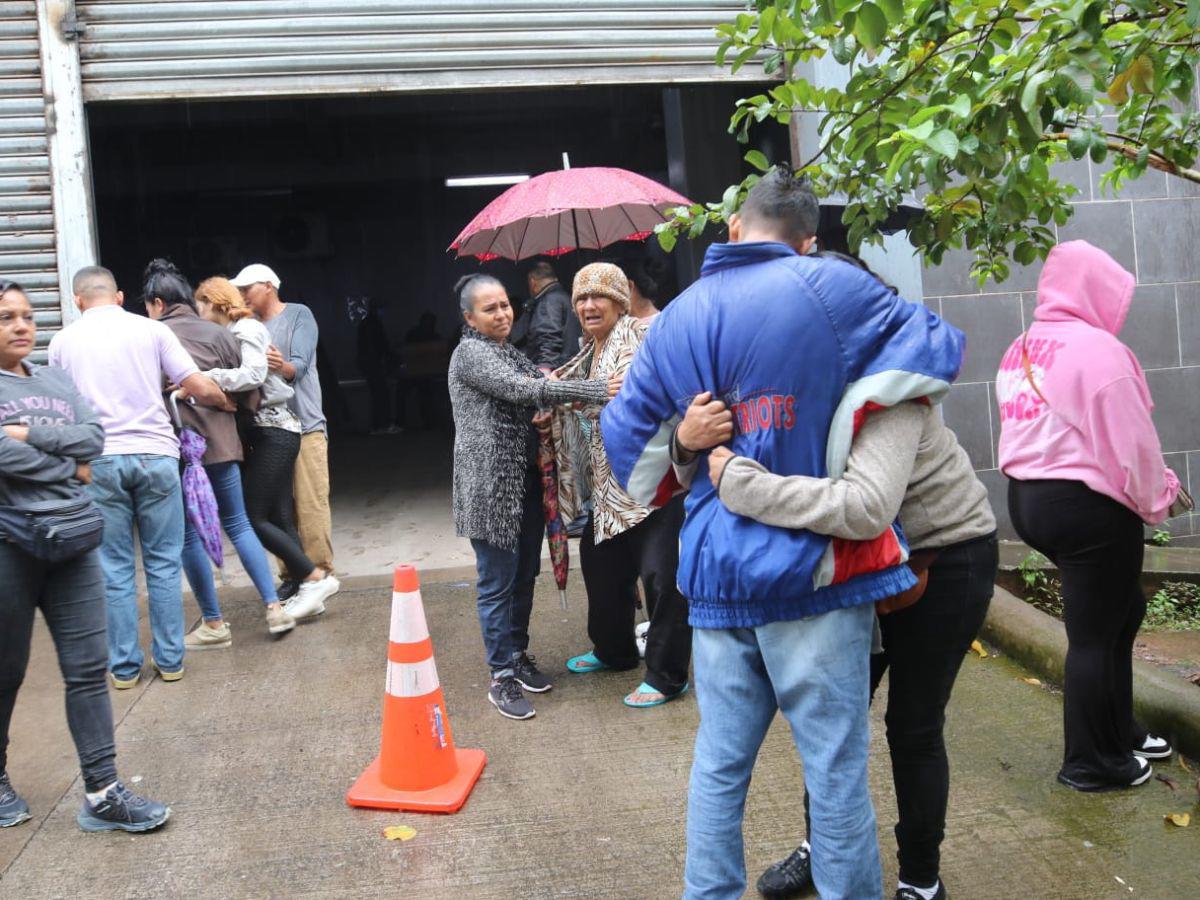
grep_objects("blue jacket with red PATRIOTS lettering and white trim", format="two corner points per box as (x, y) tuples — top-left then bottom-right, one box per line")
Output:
(600, 242), (964, 628)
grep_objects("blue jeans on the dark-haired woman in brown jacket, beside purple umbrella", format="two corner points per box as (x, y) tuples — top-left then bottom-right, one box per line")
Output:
(184, 462), (280, 622)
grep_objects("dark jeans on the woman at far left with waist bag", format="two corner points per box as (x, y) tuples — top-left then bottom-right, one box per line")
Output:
(0, 540), (116, 791)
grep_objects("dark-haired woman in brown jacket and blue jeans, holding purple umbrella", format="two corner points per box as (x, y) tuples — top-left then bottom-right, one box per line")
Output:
(142, 259), (295, 650)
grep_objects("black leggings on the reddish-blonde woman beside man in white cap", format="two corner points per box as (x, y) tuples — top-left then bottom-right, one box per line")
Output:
(242, 427), (316, 581)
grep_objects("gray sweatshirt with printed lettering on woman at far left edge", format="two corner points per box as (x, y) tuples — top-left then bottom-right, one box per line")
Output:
(0, 362), (104, 509)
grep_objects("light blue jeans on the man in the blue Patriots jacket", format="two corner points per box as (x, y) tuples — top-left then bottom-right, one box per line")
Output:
(684, 604), (883, 900)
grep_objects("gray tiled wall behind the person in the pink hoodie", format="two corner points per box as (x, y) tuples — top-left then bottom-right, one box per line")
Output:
(924, 160), (1200, 544)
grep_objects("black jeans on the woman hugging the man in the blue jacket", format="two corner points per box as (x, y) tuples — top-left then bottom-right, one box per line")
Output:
(804, 535), (1000, 887)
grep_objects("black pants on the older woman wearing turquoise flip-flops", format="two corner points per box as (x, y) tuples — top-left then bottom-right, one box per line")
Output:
(580, 494), (691, 695)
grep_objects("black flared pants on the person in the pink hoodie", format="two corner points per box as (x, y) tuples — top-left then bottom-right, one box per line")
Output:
(1008, 480), (1146, 784)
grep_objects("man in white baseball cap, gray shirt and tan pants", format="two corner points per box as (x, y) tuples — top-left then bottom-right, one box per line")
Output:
(232, 263), (336, 619)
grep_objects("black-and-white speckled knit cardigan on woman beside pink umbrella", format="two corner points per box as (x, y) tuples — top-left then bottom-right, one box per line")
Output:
(448, 326), (608, 550)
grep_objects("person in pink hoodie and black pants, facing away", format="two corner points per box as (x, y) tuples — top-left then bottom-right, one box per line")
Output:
(996, 241), (1187, 791)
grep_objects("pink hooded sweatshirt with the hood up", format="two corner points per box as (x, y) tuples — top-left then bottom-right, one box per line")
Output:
(996, 241), (1180, 524)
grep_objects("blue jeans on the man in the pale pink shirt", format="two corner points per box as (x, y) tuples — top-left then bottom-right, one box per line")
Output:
(89, 454), (184, 678)
